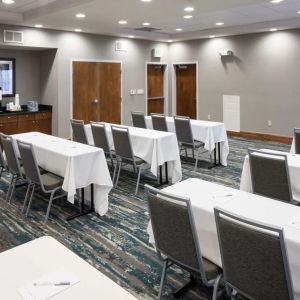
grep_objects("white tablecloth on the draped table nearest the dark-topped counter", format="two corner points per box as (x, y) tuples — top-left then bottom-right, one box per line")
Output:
(12, 132), (113, 216)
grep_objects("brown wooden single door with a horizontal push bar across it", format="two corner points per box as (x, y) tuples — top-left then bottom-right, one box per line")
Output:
(147, 65), (165, 115)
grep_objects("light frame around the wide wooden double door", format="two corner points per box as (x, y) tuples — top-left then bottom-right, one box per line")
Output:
(70, 58), (123, 124)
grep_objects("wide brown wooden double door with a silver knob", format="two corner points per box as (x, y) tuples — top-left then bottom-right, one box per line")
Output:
(73, 62), (121, 124)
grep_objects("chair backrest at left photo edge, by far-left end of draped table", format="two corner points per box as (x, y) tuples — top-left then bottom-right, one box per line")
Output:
(1, 133), (22, 176)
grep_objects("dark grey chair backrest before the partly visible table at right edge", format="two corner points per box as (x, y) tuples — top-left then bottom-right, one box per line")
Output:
(248, 149), (293, 202)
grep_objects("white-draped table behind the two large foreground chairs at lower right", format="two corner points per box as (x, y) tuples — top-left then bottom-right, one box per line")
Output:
(147, 178), (300, 300)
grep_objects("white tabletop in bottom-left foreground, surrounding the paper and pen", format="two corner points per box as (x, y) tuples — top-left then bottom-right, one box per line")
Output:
(0, 236), (136, 300)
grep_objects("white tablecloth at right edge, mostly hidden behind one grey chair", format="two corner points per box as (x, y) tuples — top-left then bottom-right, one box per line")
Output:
(240, 149), (300, 202)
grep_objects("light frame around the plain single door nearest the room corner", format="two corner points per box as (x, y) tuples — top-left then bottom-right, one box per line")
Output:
(171, 61), (199, 119)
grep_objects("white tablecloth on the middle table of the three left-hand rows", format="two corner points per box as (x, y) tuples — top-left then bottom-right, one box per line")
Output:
(85, 123), (182, 183)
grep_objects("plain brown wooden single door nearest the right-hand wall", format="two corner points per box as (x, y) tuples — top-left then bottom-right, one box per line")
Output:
(176, 64), (197, 119)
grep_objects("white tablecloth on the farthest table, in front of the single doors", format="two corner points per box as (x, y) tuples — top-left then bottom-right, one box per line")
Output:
(146, 116), (229, 166)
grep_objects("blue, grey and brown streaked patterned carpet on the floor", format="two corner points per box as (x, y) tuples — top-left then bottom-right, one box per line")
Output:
(0, 138), (290, 299)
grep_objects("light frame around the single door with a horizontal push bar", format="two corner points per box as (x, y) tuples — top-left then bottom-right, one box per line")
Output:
(145, 61), (169, 115)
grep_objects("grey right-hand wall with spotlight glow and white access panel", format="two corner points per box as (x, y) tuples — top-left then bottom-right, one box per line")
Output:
(169, 30), (300, 136)
